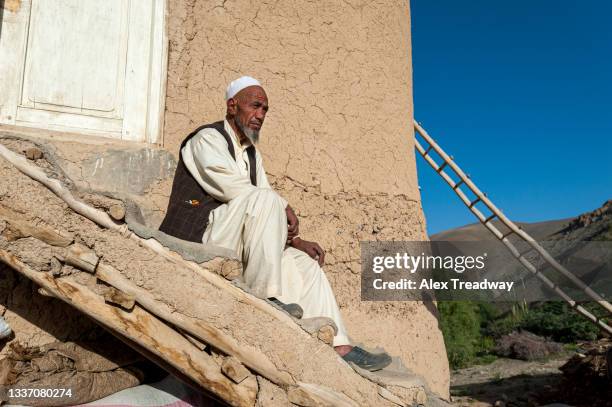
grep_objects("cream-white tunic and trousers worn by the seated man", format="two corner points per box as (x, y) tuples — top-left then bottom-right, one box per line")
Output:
(181, 120), (350, 346)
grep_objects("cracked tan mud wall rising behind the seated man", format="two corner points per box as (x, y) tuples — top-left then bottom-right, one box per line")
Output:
(164, 0), (449, 396)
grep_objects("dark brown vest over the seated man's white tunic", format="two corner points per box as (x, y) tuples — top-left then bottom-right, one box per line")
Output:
(159, 121), (257, 243)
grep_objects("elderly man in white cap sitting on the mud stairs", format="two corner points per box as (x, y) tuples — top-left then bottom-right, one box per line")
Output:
(160, 77), (391, 371)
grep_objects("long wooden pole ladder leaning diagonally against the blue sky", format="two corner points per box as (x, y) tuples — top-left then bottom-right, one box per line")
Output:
(414, 120), (612, 334)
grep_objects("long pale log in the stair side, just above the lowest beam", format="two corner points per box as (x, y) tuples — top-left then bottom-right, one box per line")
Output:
(96, 262), (295, 386)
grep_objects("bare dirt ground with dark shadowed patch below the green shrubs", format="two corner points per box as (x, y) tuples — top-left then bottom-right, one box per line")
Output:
(451, 338), (612, 407)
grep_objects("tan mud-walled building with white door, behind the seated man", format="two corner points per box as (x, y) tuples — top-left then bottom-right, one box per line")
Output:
(0, 0), (449, 398)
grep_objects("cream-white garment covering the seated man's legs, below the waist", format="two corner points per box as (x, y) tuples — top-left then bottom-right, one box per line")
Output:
(202, 188), (350, 346)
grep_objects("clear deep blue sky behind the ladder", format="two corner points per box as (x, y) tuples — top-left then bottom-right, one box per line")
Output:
(410, 0), (612, 234)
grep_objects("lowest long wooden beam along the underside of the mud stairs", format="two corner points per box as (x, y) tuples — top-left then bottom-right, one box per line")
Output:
(0, 249), (257, 406)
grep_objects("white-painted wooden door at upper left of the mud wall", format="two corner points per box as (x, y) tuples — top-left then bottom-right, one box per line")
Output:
(0, 0), (166, 142)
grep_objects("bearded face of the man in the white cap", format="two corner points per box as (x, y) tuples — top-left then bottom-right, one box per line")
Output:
(227, 86), (268, 144)
